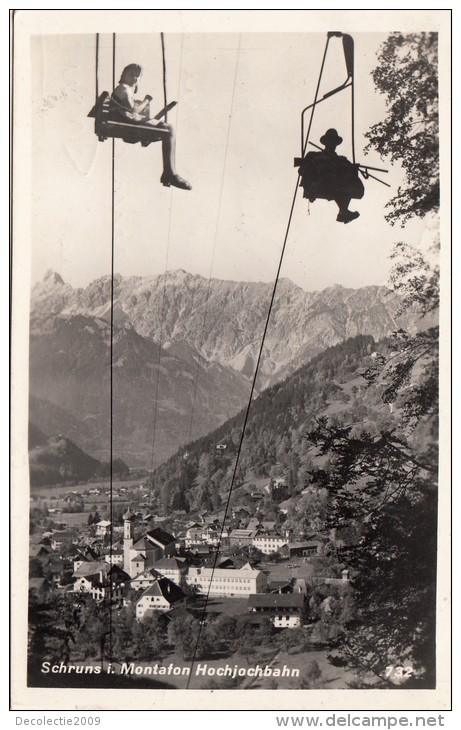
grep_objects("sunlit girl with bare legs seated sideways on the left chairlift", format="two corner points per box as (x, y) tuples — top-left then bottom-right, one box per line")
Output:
(110, 63), (192, 190)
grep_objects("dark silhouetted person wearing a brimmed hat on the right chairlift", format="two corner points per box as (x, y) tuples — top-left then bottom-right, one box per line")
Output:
(299, 129), (365, 223)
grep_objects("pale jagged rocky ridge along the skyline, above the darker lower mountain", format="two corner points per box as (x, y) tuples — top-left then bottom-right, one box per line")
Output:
(31, 269), (411, 389)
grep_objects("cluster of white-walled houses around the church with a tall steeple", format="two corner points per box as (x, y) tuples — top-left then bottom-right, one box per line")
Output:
(30, 509), (347, 628)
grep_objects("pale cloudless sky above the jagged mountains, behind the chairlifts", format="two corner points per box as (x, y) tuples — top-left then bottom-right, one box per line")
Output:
(31, 32), (430, 291)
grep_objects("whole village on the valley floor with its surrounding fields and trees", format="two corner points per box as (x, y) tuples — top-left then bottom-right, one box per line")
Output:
(29, 466), (350, 688)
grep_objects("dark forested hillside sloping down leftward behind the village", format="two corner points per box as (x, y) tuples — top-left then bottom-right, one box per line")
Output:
(150, 335), (395, 513)
